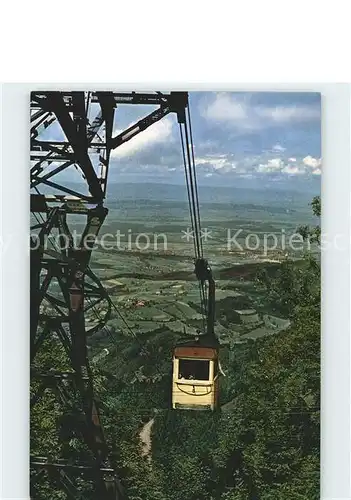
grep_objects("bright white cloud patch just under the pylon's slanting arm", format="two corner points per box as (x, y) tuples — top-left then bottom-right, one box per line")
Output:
(111, 118), (172, 158)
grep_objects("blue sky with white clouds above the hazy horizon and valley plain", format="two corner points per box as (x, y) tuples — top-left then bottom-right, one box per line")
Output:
(36, 92), (321, 185)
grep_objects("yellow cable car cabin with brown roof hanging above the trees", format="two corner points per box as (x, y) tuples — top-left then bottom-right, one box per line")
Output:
(172, 342), (219, 410)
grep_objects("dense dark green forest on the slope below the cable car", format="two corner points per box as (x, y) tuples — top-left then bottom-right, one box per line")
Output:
(31, 197), (321, 500)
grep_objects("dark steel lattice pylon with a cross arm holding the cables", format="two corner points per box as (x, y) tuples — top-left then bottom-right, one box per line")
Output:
(30, 91), (188, 500)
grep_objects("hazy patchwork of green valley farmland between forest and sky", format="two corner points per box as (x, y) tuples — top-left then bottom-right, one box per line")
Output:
(81, 185), (320, 352)
